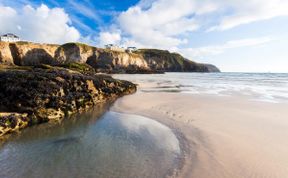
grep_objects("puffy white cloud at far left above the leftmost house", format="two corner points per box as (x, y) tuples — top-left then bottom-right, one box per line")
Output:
(0, 4), (80, 43)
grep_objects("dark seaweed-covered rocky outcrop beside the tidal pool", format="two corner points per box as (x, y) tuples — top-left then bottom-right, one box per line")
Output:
(0, 63), (136, 136)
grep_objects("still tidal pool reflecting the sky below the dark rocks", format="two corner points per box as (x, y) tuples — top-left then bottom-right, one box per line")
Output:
(0, 106), (181, 178)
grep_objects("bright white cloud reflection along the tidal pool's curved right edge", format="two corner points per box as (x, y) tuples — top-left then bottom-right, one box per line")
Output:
(109, 112), (180, 154)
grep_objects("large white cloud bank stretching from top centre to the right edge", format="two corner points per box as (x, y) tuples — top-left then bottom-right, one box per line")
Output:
(98, 0), (288, 49)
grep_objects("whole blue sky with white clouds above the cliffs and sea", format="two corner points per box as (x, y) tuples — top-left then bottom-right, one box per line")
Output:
(0, 0), (288, 72)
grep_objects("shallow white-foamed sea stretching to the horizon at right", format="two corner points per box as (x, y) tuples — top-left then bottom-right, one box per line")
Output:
(113, 72), (288, 103)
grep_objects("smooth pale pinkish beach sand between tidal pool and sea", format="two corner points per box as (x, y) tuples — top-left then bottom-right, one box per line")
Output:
(112, 92), (288, 178)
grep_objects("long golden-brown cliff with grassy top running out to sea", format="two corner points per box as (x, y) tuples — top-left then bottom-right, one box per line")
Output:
(0, 42), (220, 73)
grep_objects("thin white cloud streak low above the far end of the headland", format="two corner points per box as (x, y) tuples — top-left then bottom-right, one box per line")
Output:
(177, 37), (273, 59)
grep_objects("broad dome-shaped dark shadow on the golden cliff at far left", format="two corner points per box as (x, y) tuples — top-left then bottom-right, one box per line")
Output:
(22, 48), (57, 66)
